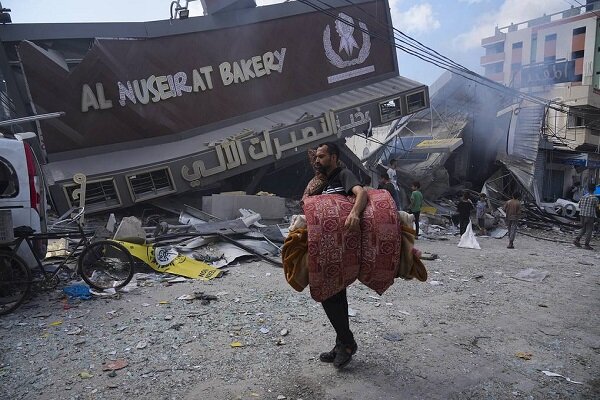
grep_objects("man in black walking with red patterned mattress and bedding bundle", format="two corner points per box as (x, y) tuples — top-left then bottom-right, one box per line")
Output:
(281, 143), (427, 368)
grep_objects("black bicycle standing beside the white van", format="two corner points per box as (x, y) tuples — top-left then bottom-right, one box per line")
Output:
(0, 207), (134, 315)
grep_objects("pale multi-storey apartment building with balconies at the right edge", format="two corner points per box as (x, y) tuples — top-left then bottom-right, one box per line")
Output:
(481, 0), (600, 201)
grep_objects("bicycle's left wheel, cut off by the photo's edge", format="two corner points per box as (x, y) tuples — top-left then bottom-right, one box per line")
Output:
(0, 250), (32, 315)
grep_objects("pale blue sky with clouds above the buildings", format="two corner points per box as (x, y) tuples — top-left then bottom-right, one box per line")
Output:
(1, 0), (585, 85)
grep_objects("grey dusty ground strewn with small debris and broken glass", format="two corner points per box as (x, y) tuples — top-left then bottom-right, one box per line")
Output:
(0, 231), (600, 400)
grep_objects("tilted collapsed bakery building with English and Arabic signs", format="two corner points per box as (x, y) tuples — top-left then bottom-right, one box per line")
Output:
(0, 0), (429, 213)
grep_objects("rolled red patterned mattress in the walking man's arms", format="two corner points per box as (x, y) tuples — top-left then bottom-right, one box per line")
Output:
(304, 190), (401, 302)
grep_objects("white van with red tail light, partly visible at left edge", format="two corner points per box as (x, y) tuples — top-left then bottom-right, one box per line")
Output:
(0, 133), (47, 260)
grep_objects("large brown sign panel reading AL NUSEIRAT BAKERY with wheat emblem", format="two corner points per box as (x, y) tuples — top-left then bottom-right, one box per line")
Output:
(18, 0), (397, 155)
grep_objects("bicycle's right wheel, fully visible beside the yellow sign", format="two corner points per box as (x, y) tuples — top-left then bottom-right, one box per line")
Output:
(78, 240), (133, 290)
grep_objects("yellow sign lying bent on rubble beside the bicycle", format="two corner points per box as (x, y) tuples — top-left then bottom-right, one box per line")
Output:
(119, 241), (222, 281)
